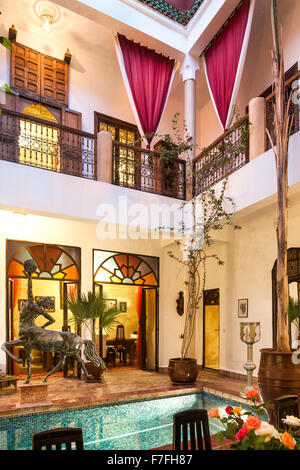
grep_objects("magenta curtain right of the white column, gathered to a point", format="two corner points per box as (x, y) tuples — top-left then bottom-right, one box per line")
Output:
(205, 0), (250, 129)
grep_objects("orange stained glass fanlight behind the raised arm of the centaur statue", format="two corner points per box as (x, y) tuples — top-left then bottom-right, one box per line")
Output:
(7, 242), (80, 281)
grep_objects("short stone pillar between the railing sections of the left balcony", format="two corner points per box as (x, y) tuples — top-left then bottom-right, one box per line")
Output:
(97, 131), (113, 184)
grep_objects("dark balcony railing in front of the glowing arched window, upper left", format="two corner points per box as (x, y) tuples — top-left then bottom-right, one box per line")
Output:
(0, 110), (96, 179)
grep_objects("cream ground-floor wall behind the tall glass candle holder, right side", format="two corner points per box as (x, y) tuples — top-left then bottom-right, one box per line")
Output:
(197, 185), (300, 374)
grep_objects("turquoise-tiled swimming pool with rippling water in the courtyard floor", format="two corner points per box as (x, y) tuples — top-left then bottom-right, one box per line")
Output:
(0, 392), (246, 450)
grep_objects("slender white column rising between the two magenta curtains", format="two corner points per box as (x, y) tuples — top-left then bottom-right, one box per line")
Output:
(181, 55), (199, 200)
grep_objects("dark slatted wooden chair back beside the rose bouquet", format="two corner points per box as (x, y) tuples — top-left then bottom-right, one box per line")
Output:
(173, 409), (211, 450)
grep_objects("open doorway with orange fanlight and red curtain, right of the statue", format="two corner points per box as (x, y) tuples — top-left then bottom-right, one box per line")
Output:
(93, 250), (159, 370)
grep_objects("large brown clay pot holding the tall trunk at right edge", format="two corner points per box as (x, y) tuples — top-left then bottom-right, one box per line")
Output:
(258, 349), (300, 421)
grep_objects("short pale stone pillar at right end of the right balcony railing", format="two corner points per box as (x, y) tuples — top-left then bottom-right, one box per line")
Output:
(249, 97), (266, 161)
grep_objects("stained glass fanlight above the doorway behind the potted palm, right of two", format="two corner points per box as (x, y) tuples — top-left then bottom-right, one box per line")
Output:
(94, 250), (158, 286)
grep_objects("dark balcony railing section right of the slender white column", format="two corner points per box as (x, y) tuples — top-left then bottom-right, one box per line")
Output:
(193, 115), (249, 196)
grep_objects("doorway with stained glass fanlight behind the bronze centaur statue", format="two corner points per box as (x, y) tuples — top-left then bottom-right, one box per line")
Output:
(6, 240), (81, 375)
